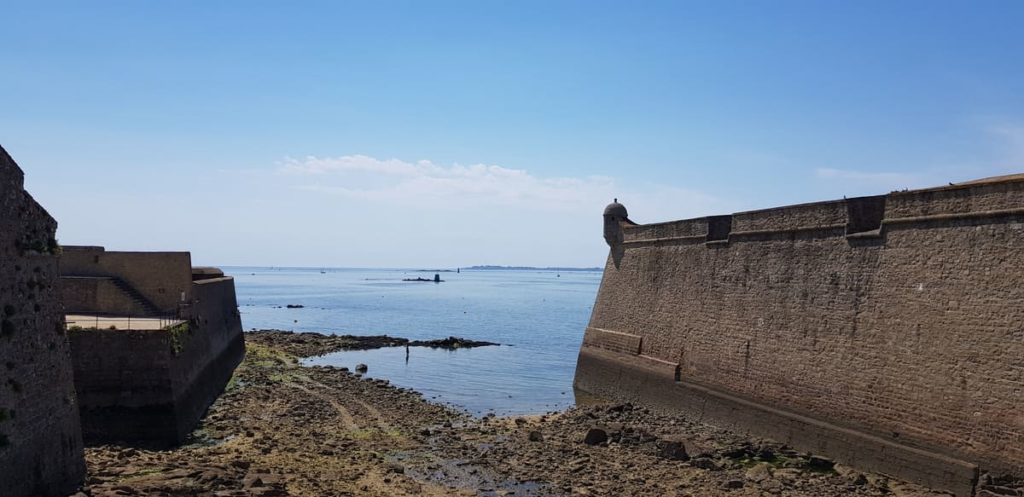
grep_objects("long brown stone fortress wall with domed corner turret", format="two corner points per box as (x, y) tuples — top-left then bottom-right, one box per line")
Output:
(575, 177), (1024, 495)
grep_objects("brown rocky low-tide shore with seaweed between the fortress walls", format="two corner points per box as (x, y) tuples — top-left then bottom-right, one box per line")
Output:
(78, 331), (1010, 497)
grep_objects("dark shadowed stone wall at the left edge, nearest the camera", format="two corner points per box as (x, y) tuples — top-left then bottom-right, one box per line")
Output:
(0, 148), (85, 497)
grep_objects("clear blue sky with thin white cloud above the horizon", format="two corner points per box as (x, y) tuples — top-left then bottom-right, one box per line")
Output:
(0, 1), (1024, 266)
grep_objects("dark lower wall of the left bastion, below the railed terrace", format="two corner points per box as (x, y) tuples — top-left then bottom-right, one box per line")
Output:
(70, 277), (245, 445)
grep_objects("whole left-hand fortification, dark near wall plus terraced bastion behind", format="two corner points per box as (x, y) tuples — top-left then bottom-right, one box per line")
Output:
(0, 142), (245, 491)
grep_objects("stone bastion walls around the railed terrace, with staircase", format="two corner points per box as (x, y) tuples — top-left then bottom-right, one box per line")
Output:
(60, 247), (245, 445)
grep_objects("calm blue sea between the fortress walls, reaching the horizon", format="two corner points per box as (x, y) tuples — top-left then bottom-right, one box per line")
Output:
(225, 267), (601, 415)
